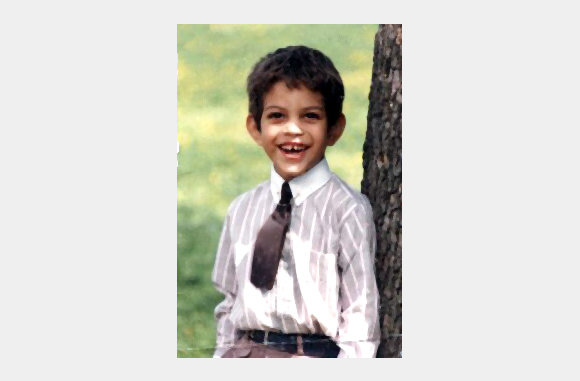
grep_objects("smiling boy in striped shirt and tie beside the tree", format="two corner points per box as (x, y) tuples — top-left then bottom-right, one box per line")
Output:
(212, 46), (380, 357)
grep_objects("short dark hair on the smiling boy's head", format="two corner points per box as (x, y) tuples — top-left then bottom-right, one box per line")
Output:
(247, 46), (344, 130)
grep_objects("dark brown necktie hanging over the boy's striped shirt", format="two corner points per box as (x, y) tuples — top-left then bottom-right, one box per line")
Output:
(250, 182), (292, 290)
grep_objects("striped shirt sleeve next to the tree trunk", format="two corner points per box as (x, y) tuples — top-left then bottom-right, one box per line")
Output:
(337, 198), (380, 358)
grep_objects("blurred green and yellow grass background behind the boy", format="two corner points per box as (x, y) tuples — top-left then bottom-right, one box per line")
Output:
(177, 25), (378, 357)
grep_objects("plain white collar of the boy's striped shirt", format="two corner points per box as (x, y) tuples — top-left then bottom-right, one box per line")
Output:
(270, 158), (332, 205)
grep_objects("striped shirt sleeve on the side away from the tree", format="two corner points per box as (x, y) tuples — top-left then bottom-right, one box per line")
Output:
(212, 205), (237, 357)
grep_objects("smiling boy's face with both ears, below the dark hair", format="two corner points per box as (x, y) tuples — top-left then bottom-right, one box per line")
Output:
(246, 81), (346, 181)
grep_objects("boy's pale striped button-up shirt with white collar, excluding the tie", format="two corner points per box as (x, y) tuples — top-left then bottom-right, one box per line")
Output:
(212, 159), (380, 357)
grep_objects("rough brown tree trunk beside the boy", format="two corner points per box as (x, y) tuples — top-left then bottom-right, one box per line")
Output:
(361, 24), (402, 357)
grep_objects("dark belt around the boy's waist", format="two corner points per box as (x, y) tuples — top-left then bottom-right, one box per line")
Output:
(247, 330), (340, 357)
